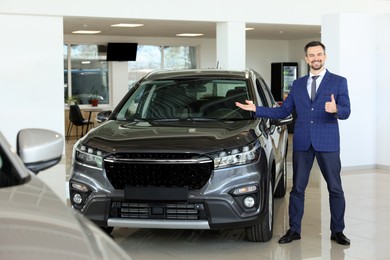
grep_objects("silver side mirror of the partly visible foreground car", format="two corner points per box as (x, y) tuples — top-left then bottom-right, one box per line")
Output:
(17, 128), (64, 174)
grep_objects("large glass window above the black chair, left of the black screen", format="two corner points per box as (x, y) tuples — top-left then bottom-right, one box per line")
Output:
(64, 44), (110, 104)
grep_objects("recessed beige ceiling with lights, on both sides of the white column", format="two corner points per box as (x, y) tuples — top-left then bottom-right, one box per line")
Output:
(64, 17), (321, 40)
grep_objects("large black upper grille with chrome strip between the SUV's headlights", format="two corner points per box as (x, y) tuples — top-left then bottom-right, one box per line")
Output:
(104, 153), (213, 190)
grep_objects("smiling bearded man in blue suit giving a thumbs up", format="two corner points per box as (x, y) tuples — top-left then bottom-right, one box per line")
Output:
(236, 41), (351, 245)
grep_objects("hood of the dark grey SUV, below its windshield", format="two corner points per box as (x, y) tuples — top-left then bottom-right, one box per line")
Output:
(83, 119), (260, 153)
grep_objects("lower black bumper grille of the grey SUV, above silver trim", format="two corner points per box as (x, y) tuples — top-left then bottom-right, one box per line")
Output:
(110, 201), (207, 220)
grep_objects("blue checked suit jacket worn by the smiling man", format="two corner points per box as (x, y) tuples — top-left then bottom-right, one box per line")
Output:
(256, 71), (351, 152)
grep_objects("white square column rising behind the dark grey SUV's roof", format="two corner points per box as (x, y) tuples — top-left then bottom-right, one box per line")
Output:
(216, 22), (246, 70)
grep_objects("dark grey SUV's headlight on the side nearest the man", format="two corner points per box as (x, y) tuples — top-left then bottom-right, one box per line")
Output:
(214, 144), (260, 169)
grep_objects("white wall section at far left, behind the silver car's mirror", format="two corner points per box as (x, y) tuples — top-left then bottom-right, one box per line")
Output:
(0, 14), (64, 147)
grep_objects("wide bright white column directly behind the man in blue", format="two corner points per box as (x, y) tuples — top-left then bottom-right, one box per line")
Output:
(321, 14), (378, 167)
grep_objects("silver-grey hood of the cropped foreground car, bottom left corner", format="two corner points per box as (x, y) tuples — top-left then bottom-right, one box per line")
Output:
(0, 176), (130, 260)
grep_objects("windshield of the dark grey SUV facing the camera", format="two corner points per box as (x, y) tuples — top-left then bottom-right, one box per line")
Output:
(117, 78), (253, 120)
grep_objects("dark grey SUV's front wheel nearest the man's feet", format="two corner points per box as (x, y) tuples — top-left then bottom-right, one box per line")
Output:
(245, 181), (274, 242)
